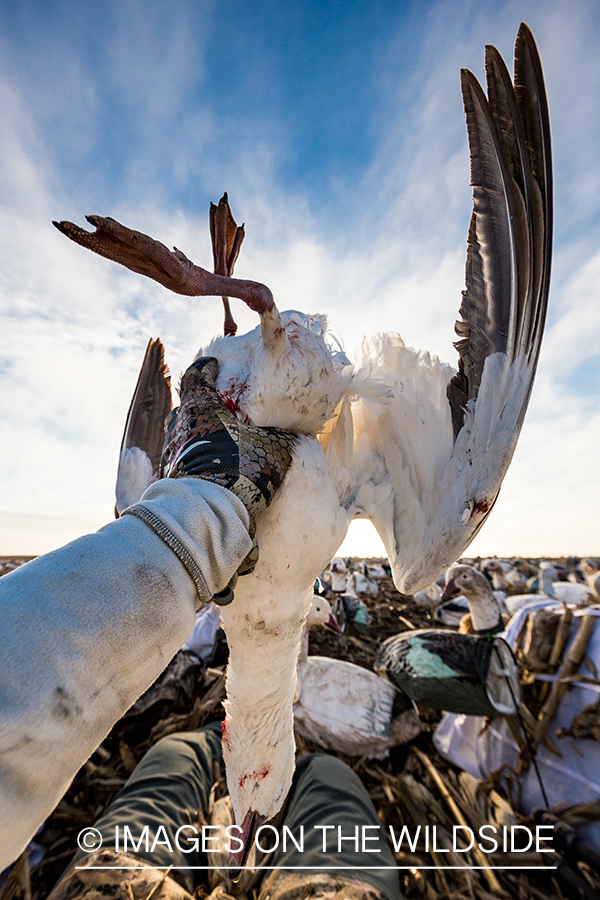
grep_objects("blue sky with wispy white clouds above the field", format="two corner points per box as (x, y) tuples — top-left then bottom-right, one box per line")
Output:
(0, 0), (600, 555)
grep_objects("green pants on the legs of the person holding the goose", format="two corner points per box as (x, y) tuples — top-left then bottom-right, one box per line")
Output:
(70, 723), (400, 900)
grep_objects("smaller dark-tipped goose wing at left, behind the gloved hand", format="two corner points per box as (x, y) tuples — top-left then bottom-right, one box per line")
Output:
(115, 338), (173, 516)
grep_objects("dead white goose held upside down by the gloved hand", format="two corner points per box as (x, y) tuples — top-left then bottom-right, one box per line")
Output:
(58, 25), (552, 864)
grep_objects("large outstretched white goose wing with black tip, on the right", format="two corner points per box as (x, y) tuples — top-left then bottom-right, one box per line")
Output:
(342, 24), (552, 593)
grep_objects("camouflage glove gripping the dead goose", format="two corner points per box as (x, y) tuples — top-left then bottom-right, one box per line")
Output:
(162, 356), (296, 603)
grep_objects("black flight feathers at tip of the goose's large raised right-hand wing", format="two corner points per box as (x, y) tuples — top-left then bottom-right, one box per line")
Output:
(447, 24), (552, 439)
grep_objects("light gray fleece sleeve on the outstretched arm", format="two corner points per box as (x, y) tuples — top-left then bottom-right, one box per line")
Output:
(0, 478), (252, 871)
